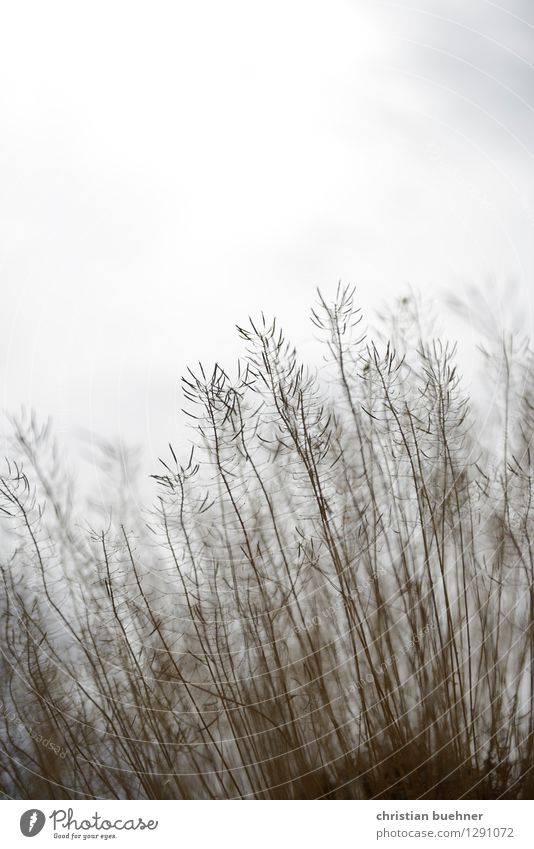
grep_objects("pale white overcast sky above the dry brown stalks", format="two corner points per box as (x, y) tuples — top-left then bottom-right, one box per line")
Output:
(0, 0), (534, 484)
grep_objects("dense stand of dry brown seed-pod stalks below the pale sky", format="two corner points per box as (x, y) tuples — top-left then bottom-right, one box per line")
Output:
(0, 289), (534, 799)
